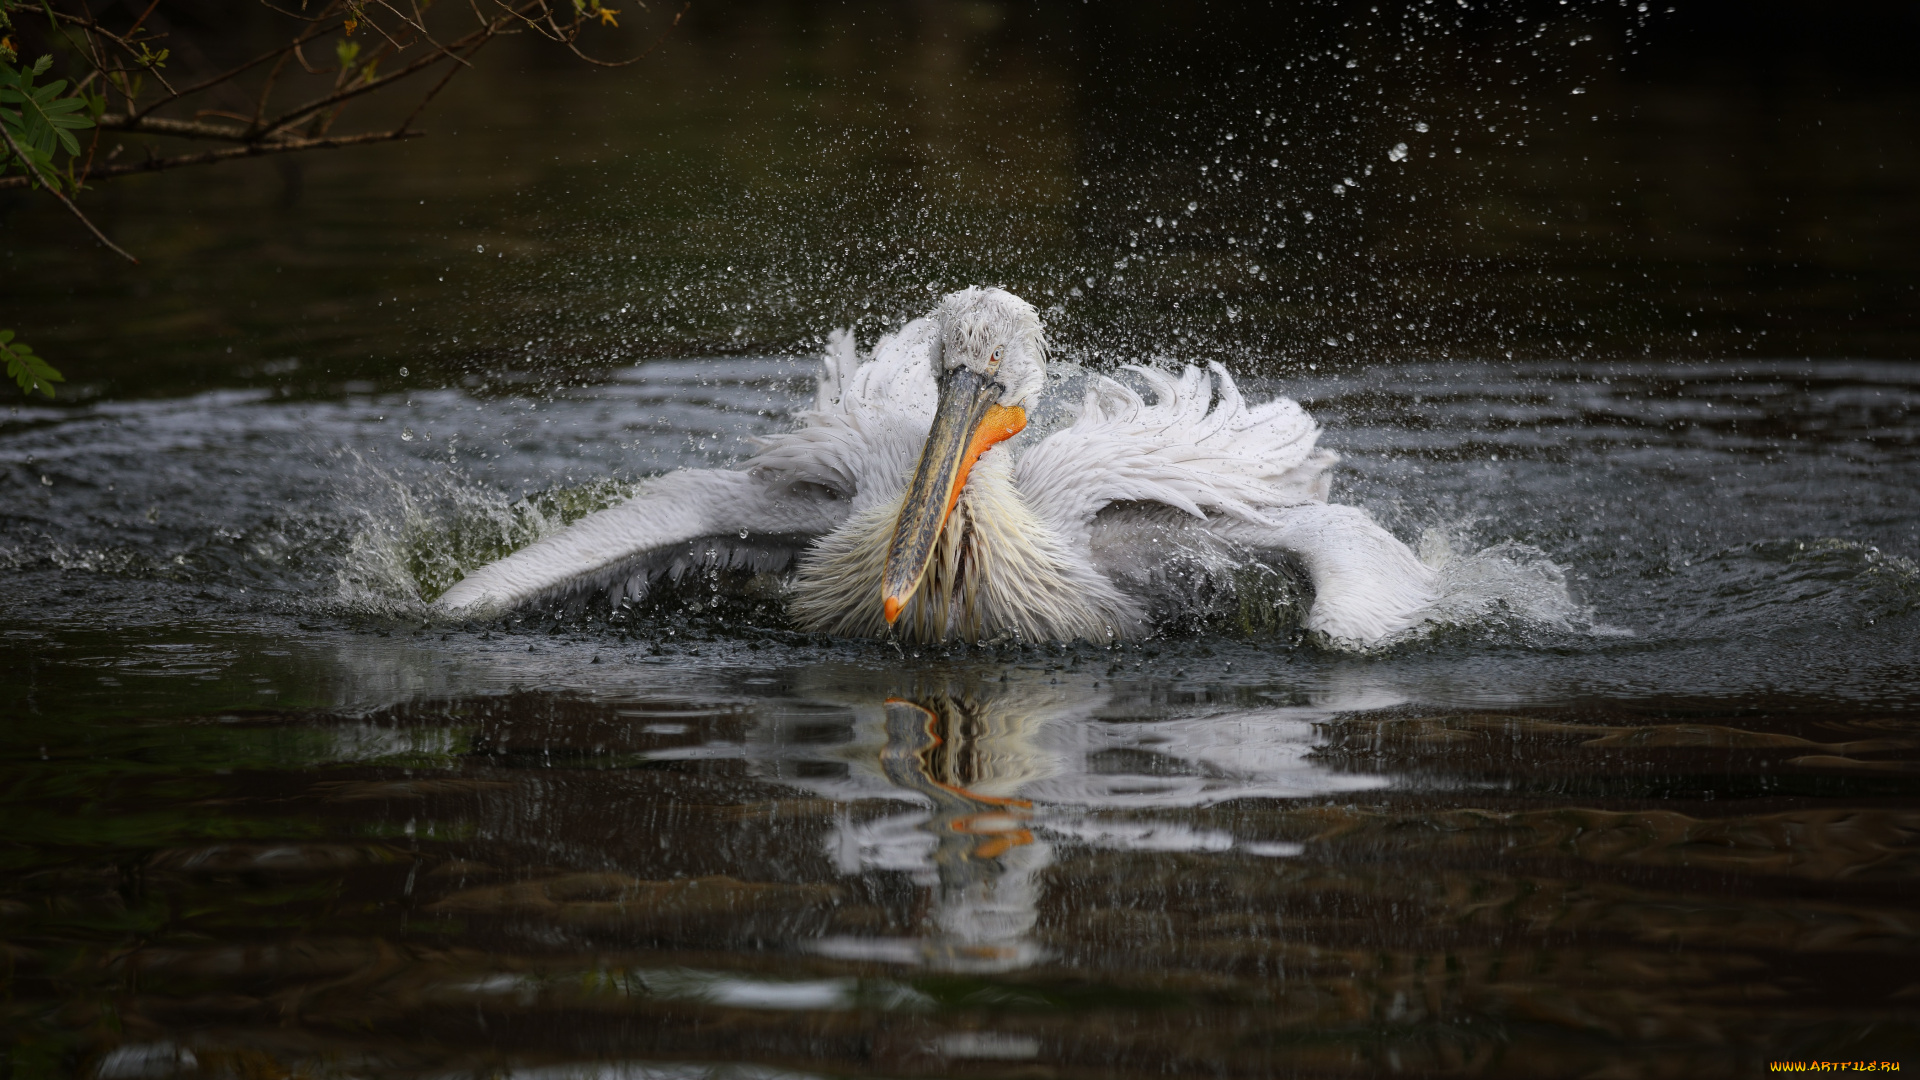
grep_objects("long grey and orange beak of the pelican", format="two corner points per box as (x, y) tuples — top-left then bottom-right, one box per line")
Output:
(879, 367), (1027, 625)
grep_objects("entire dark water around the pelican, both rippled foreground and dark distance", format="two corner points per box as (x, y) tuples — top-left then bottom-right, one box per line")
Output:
(0, 4), (1920, 1080)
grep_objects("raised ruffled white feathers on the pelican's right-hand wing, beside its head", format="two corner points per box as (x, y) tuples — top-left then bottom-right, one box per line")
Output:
(1014, 363), (1338, 542)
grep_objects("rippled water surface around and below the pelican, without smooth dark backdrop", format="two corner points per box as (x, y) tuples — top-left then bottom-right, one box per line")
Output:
(0, 351), (1920, 1076)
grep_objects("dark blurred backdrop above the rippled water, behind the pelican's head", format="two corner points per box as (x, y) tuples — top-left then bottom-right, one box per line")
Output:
(0, 0), (1920, 400)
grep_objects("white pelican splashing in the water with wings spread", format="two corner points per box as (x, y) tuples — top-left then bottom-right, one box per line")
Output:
(436, 286), (1436, 648)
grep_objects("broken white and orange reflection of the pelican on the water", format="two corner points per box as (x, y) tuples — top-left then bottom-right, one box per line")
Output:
(725, 671), (1390, 970)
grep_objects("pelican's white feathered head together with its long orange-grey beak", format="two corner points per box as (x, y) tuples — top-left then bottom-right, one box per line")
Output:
(881, 288), (1046, 623)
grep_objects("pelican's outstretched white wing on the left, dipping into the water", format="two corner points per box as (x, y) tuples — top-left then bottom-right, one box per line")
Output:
(434, 469), (847, 617)
